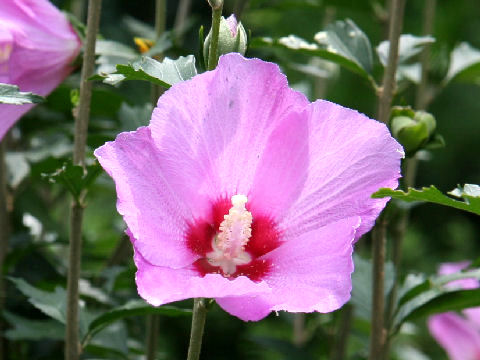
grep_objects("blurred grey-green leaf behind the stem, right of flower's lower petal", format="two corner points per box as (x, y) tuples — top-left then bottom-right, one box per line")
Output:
(352, 254), (395, 321)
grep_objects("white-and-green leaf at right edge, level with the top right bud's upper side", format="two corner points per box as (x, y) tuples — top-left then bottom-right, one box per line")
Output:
(443, 42), (480, 85)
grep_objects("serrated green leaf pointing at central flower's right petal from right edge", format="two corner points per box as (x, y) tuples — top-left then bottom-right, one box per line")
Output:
(372, 184), (480, 215)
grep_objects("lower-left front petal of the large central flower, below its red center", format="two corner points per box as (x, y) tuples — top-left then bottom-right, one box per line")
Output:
(134, 240), (270, 306)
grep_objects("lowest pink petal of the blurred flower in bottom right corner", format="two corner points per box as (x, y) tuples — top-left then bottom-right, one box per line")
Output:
(428, 313), (480, 360)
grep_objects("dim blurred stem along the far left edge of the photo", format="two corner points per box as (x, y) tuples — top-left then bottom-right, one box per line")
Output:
(0, 138), (10, 360)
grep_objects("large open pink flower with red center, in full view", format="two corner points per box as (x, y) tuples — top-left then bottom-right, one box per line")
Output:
(95, 54), (403, 320)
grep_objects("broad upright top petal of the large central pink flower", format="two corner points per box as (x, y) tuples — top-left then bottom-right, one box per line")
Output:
(150, 53), (308, 215)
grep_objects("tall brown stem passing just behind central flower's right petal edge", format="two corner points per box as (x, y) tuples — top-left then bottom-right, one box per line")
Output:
(369, 0), (405, 360)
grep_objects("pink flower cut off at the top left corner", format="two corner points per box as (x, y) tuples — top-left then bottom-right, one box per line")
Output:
(0, 0), (81, 140)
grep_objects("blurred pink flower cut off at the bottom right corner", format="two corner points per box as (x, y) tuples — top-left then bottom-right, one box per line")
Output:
(428, 261), (480, 360)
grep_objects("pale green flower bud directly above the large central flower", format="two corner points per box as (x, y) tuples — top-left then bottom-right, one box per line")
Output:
(203, 14), (247, 67)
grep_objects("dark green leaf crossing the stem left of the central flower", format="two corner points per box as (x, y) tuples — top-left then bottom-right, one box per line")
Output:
(42, 161), (102, 202)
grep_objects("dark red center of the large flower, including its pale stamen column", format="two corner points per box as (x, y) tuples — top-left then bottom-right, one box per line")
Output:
(186, 195), (280, 281)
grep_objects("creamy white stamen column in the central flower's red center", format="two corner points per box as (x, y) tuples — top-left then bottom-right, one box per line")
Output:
(207, 195), (252, 276)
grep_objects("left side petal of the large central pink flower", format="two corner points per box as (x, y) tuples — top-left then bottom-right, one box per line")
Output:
(95, 127), (207, 267)
